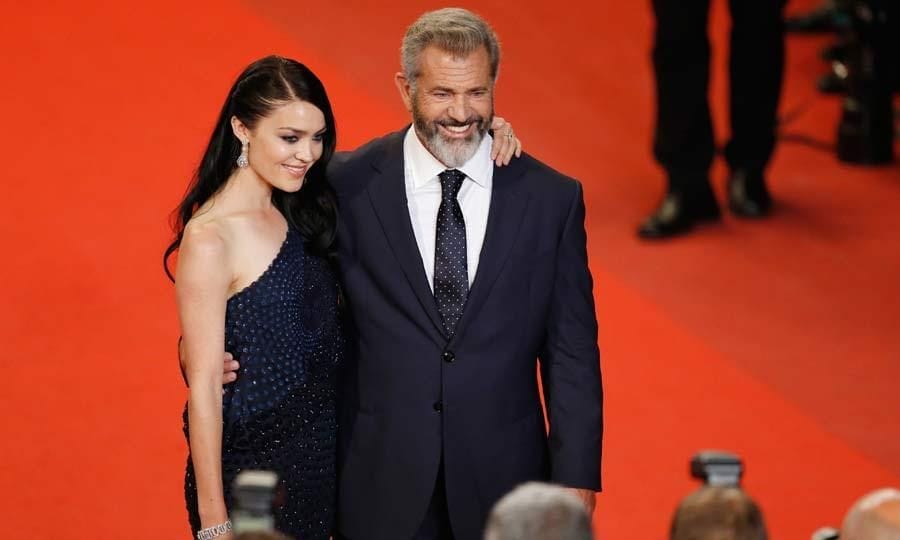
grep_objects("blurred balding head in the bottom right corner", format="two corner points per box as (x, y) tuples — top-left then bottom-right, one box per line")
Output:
(841, 488), (900, 540)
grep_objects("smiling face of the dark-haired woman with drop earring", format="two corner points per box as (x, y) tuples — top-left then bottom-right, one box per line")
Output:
(235, 100), (325, 192)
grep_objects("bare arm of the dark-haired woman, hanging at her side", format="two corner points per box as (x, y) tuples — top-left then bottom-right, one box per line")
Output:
(175, 224), (233, 528)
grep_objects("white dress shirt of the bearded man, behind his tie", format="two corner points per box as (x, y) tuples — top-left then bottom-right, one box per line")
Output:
(403, 126), (494, 291)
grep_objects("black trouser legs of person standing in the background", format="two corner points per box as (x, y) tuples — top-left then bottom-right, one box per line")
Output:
(653, 0), (785, 193)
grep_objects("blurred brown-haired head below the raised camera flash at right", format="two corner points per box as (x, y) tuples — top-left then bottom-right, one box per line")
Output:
(669, 486), (768, 540)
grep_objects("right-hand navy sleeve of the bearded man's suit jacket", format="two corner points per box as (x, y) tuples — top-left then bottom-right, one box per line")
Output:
(540, 182), (603, 491)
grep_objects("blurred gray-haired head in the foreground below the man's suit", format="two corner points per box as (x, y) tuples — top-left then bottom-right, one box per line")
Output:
(484, 482), (593, 540)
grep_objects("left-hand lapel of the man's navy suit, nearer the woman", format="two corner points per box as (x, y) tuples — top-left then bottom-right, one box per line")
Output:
(368, 129), (446, 339)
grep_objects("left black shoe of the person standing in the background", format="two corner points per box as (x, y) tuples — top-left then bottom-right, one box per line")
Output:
(637, 191), (720, 240)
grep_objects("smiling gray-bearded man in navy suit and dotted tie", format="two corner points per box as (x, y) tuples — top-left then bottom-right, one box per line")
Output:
(329, 9), (602, 540)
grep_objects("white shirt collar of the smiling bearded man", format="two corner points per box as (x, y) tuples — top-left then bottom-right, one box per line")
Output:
(403, 126), (494, 189)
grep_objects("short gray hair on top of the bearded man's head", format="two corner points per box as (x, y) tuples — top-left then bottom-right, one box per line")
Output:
(400, 8), (500, 86)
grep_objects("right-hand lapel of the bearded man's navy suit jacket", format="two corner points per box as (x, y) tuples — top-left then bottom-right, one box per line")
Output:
(454, 159), (528, 338)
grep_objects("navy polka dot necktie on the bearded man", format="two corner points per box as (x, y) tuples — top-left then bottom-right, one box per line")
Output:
(434, 169), (469, 336)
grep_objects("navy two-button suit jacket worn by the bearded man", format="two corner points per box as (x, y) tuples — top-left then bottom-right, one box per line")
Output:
(329, 130), (603, 540)
